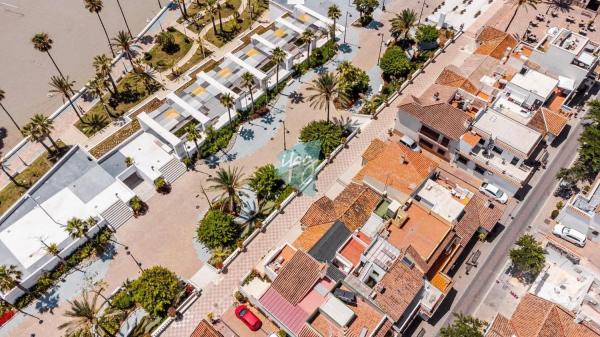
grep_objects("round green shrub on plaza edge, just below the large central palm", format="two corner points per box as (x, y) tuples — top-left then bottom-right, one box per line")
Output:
(196, 209), (239, 249)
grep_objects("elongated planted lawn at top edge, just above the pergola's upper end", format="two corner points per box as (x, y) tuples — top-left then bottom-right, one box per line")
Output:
(204, 0), (269, 47)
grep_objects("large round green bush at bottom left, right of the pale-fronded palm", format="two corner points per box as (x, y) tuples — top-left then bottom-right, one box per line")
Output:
(131, 266), (181, 317)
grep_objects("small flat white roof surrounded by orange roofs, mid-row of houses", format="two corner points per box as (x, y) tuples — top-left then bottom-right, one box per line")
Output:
(417, 179), (465, 222)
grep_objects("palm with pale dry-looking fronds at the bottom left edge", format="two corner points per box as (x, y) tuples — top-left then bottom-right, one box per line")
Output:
(58, 290), (122, 336)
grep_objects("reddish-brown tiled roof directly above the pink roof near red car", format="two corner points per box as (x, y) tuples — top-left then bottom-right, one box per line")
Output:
(271, 250), (323, 305)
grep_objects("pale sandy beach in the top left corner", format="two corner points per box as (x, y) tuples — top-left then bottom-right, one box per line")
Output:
(0, 0), (166, 151)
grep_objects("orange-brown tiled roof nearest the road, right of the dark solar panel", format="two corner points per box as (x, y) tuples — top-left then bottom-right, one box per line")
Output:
(375, 258), (424, 322)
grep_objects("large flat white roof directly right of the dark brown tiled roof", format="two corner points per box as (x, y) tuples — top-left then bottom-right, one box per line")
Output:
(473, 109), (542, 154)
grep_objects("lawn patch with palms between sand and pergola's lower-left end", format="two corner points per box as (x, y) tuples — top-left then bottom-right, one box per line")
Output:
(75, 72), (159, 137)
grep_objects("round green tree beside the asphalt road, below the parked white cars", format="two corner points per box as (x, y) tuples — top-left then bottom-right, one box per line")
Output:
(509, 234), (546, 275)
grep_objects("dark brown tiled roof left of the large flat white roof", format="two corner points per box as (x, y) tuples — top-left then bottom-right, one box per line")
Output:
(398, 95), (471, 140)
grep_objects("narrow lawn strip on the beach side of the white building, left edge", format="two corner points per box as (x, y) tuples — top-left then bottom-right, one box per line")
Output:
(0, 144), (67, 214)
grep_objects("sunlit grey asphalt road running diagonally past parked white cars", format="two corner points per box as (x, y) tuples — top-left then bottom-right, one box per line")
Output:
(443, 116), (583, 326)
